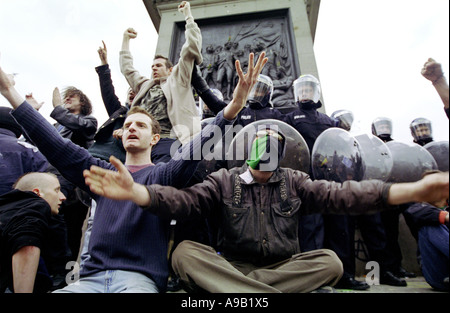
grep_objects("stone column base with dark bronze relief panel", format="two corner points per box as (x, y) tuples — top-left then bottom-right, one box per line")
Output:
(144, 0), (325, 112)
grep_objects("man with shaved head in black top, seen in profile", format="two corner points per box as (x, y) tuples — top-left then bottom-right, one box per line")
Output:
(0, 172), (66, 293)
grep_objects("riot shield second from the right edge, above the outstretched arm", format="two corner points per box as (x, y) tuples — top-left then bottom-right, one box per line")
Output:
(386, 140), (438, 183)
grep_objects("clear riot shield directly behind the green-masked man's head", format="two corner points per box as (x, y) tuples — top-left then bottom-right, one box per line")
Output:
(225, 119), (310, 173)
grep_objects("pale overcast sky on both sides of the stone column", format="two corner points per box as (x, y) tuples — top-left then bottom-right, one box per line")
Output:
(0, 0), (449, 142)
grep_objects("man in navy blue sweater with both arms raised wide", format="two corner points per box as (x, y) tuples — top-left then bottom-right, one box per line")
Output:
(0, 54), (267, 293)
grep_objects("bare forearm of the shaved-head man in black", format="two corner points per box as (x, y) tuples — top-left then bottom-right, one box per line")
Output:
(12, 246), (41, 293)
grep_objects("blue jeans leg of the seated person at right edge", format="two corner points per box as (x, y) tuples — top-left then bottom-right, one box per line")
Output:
(419, 225), (449, 291)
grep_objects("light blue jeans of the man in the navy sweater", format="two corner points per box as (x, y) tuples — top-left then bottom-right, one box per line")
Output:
(54, 270), (158, 293)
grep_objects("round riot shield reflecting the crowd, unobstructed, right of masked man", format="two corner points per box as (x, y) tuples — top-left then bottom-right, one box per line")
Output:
(311, 128), (365, 182)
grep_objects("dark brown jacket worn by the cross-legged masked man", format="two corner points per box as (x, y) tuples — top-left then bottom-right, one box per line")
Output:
(144, 166), (390, 265)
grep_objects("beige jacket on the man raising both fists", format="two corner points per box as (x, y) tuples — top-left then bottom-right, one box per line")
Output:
(120, 20), (203, 144)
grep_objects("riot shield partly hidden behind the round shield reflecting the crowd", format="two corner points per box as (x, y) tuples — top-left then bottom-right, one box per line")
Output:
(355, 134), (394, 181)
